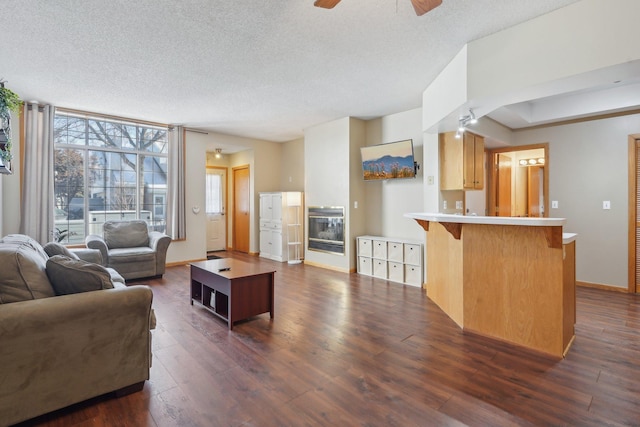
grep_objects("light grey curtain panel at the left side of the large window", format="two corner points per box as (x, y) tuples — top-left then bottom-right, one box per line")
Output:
(20, 103), (54, 244)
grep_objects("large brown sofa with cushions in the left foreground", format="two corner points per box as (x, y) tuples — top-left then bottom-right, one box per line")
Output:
(0, 235), (155, 426)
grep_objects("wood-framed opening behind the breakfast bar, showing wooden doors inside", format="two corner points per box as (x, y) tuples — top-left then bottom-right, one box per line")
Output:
(487, 144), (549, 217)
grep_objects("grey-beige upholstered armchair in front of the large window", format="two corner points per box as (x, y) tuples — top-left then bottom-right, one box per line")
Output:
(85, 220), (171, 280)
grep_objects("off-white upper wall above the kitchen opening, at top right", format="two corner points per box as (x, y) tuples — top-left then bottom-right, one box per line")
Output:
(468, 0), (640, 106)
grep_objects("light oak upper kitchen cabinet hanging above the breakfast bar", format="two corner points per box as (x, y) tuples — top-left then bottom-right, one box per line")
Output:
(440, 131), (484, 190)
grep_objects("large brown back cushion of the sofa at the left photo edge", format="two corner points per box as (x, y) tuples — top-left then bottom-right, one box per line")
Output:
(0, 244), (55, 304)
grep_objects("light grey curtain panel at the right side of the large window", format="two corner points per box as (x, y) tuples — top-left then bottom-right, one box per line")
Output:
(167, 126), (187, 240)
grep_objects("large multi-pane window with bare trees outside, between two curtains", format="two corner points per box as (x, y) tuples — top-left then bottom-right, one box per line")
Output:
(54, 112), (168, 243)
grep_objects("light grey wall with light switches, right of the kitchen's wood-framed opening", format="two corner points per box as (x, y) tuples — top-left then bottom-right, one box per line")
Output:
(514, 115), (640, 289)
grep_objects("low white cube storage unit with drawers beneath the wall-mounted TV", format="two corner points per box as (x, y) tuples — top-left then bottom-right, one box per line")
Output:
(357, 236), (423, 286)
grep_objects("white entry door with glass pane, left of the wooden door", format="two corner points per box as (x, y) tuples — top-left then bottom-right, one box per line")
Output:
(206, 167), (227, 252)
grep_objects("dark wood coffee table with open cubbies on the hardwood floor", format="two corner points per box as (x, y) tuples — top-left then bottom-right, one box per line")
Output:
(191, 258), (275, 330)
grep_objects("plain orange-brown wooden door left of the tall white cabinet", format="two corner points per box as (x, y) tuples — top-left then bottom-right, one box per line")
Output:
(232, 165), (251, 253)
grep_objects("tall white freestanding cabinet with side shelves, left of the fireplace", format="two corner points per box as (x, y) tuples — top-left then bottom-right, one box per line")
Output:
(260, 192), (302, 262)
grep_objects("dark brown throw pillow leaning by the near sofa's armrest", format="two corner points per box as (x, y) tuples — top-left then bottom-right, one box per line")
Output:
(47, 255), (113, 295)
